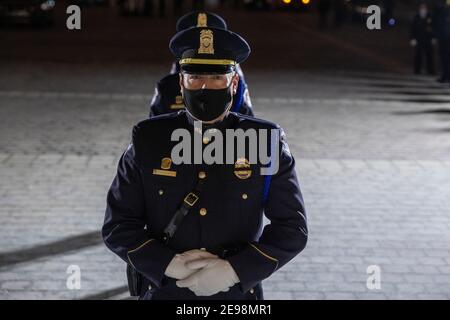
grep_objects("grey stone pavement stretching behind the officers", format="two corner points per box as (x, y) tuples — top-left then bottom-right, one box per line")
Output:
(0, 63), (450, 299)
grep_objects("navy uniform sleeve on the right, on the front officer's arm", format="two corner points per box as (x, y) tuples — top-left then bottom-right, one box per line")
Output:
(228, 129), (308, 292)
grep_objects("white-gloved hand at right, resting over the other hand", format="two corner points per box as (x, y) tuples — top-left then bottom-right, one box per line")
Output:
(177, 258), (239, 296)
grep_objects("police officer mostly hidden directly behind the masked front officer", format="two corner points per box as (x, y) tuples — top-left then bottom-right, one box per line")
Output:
(149, 12), (253, 117)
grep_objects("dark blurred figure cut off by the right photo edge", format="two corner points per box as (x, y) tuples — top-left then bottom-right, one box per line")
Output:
(433, 0), (450, 83)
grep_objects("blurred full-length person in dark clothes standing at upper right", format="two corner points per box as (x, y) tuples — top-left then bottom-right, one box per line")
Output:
(410, 2), (436, 75)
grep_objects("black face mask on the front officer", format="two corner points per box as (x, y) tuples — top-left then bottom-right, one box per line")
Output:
(183, 85), (233, 121)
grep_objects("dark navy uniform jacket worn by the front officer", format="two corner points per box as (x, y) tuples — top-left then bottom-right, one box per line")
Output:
(102, 111), (307, 299)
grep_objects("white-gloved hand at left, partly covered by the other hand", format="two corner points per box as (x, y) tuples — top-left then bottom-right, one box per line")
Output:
(164, 249), (217, 279)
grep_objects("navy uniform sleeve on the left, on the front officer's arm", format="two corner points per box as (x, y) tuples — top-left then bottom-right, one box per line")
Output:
(102, 139), (175, 287)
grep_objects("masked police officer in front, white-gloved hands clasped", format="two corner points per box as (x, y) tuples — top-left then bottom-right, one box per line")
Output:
(102, 27), (307, 300)
